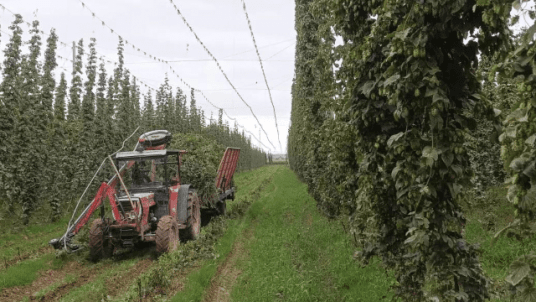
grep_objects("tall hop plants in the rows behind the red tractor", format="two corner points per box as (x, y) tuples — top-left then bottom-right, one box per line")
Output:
(0, 15), (265, 224)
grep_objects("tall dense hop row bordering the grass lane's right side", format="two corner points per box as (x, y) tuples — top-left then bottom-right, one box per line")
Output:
(289, 0), (510, 301)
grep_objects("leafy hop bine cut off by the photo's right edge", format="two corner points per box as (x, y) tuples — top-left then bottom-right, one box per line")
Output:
(496, 5), (536, 301)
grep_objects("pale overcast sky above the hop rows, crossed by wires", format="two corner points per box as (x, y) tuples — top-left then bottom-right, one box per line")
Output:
(0, 0), (296, 153)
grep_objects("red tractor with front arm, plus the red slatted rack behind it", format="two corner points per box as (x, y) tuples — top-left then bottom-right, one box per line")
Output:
(49, 130), (240, 260)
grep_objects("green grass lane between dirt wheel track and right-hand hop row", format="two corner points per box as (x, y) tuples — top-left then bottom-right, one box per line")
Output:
(232, 167), (394, 301)
